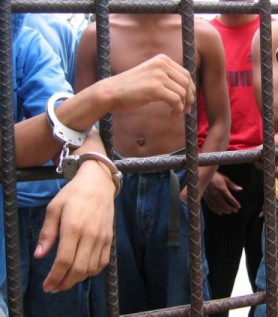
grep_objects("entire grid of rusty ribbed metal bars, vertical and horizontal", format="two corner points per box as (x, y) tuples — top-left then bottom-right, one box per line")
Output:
(0, 0), (278, 317)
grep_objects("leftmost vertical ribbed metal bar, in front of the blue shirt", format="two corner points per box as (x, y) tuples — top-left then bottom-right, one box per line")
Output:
(0, 0), (23, 317)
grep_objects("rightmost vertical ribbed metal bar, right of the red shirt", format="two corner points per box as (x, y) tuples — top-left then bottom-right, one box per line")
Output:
(259, 0), (278, 317)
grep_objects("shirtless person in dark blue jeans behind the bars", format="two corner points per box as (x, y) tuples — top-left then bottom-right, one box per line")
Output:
(76, 14), (230, 314)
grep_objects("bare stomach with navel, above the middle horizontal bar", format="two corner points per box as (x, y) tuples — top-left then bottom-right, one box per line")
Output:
(112, 105), (185, 157)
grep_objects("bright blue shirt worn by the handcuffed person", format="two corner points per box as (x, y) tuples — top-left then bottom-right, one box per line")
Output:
(0, 27), (72, 309)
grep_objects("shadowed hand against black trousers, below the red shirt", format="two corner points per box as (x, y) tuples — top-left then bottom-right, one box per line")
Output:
(203, 172), (242, 215)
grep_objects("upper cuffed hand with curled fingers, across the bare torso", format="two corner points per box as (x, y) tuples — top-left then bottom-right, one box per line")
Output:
(99, 54), (196, 116)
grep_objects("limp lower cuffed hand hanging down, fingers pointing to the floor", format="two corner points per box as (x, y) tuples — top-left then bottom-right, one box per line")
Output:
(34, 161), (115, 293)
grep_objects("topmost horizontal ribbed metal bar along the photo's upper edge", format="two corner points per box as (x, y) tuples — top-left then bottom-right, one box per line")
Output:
(8, 0), (278, 14)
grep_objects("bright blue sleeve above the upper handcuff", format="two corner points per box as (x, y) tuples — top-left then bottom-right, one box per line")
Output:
(16, 28), (72, 118)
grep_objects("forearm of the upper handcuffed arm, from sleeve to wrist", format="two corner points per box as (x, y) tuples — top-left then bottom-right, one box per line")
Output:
(12, 87), (109, 167)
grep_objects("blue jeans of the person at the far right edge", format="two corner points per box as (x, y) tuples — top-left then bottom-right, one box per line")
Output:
(253, 201), (278, 317)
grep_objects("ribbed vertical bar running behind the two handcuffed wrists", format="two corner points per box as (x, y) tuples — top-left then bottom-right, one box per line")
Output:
(95, 0), (119, 316)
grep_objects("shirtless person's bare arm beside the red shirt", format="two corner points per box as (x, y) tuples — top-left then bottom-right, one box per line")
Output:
(195, 21), (231, 194)
